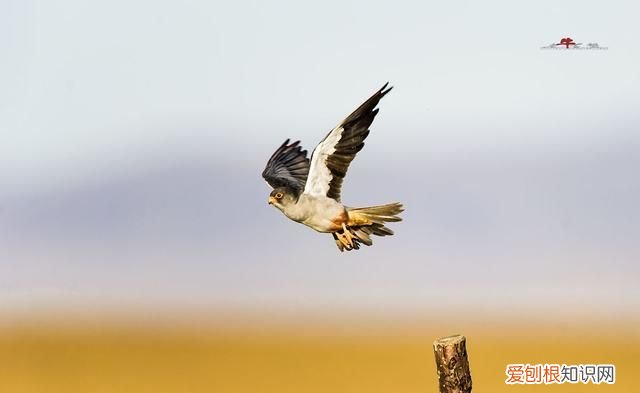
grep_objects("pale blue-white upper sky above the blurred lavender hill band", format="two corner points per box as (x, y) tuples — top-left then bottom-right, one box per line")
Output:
(0, 0), (640, 191)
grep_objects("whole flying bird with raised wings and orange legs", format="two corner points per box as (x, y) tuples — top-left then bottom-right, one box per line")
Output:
(262, 82), (404, 252)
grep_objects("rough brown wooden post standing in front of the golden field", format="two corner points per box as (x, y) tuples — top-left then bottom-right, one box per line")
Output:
(433, 335), (471, 393)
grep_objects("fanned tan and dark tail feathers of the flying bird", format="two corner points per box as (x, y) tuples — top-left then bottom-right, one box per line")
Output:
(333, 202), (404, 251)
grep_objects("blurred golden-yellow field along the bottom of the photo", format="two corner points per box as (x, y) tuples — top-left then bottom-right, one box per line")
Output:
(0, 316), (640, 393)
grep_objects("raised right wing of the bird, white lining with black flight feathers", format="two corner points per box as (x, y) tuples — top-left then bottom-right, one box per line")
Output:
(304, 82), (392, 201)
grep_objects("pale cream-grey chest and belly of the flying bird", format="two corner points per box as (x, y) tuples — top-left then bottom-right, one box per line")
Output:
(282, 194), (346, 232)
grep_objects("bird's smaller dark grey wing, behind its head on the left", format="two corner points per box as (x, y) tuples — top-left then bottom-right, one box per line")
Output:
(262, 139), (309, 194)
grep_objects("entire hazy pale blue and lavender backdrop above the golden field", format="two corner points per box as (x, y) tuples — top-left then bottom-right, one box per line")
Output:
(0, 0), (640, 307)
